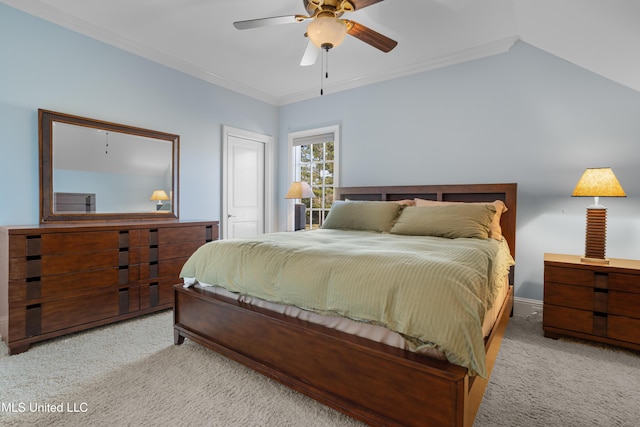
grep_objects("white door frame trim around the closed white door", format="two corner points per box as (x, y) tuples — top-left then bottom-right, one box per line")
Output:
(219, 125), (274, 239)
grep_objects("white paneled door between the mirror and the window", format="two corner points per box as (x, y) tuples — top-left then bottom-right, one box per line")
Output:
(222, 126), (271, 239)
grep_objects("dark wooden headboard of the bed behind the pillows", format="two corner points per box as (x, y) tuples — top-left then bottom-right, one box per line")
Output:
(335, 184), (518, 272)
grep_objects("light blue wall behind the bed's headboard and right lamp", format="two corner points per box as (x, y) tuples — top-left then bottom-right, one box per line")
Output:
(279, 42), (640, 300)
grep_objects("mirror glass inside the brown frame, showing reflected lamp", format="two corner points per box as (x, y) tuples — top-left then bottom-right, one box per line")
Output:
(52, 122), (173, 213)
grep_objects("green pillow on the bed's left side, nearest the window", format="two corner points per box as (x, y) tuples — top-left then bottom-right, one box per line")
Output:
(322, 200), (402, 232)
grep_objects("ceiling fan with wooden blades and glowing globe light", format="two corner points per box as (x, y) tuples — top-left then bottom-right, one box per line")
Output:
(233, 0), (398, 66)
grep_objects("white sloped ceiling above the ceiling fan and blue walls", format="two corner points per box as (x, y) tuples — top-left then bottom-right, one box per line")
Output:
(0, 0), (640, 105)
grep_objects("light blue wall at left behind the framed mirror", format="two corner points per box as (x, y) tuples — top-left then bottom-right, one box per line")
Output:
(0, 4), (278, 225)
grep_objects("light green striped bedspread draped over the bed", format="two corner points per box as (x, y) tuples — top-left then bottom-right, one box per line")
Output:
(180, 229), (513, 377)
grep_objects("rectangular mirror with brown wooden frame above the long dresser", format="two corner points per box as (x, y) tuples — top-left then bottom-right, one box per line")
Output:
(38, 109), (180, 223)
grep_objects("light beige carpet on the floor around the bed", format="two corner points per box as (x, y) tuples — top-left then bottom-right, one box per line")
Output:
(0, 312), (640, 427)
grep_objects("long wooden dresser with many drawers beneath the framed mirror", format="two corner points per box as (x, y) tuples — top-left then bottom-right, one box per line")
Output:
(0, 221), (218, 354)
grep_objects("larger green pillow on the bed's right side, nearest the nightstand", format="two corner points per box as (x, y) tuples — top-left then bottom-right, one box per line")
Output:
(391, 203), (496, 239)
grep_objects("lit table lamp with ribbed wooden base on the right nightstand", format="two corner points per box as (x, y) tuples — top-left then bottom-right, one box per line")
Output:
(571, 168), (627, 264)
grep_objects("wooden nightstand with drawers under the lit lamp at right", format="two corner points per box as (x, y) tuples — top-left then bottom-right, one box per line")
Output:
(542, 254), (640, 350)
